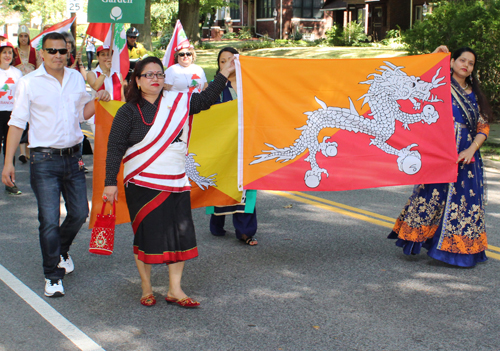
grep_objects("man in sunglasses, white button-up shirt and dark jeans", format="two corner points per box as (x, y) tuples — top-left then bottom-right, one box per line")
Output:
(2, 33), (110, 297)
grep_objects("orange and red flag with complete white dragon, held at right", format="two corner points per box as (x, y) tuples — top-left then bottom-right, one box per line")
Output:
(237, 54), (457, 191)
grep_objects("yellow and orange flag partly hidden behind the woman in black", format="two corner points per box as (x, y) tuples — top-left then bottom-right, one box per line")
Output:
(89, 101), (242, 228)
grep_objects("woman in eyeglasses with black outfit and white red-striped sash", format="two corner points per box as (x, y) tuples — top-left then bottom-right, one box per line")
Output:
(103, 57), (234, 307)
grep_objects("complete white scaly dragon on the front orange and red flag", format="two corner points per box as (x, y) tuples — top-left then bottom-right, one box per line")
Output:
(250, 61), (446, 188)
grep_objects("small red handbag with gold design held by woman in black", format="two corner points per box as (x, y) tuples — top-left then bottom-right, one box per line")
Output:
(89, 201), (116, 255)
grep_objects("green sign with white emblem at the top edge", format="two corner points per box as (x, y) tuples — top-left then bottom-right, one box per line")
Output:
(87, 0), (146, 24)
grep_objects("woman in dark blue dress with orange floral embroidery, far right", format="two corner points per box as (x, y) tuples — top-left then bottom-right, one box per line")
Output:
(389, 46), (492, 267)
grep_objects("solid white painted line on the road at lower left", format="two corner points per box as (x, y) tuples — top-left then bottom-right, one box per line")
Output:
(0, 264), (104, 351)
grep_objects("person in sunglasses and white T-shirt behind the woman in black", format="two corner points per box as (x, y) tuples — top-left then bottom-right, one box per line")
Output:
(164, 43), (208, 93)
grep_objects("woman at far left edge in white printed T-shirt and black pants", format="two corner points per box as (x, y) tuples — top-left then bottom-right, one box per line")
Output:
(0, 41), (23, 195)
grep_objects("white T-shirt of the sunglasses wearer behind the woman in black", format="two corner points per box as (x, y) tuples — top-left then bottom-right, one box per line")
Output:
(165, 63), (207, 93)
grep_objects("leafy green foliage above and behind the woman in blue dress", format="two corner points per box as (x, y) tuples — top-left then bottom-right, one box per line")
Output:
(403, 0), (500, 114)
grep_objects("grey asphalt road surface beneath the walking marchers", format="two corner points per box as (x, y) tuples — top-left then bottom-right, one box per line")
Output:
(0, 148), (500, 351)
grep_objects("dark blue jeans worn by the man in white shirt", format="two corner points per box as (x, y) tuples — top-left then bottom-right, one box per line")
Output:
(30, 151), (89, 279)
